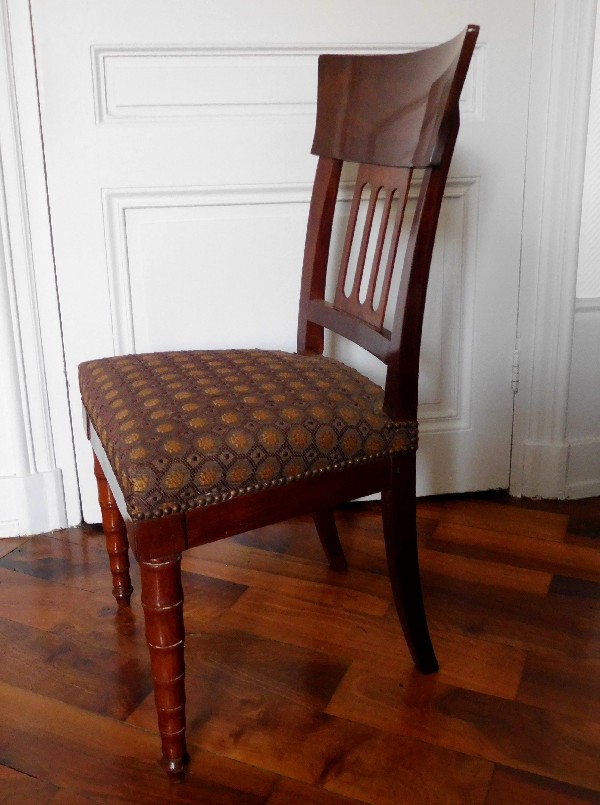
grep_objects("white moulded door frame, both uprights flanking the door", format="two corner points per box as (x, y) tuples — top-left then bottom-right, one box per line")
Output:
(0, 0), (597, 533)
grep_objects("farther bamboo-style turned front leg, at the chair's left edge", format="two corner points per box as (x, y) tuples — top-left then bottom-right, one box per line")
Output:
(94, 456), (133, 606)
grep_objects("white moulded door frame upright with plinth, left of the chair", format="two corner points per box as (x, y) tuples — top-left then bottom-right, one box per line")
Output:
(0, 0), (72, 536)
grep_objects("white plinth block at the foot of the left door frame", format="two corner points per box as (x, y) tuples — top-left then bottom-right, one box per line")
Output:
(0, 470), (67, 538)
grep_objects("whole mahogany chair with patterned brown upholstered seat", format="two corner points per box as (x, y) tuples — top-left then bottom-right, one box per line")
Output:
(79, 26), (478, 775)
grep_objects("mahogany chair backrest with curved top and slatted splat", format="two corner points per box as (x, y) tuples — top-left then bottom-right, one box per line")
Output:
(298, 25), (479, 420)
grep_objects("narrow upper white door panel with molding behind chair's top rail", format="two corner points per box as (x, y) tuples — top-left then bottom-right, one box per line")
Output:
(91, 42), (485, 125)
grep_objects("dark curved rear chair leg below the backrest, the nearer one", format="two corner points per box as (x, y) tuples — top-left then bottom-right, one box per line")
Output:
(382, 451), (439, 674)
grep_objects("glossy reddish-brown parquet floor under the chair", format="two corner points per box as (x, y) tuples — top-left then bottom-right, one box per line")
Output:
(0, 490), (600, 805)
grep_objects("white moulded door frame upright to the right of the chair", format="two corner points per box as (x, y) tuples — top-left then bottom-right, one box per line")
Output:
(511, 0), (596, 498)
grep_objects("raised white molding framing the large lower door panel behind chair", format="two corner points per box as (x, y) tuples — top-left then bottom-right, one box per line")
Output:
(102, 177), (478, 431)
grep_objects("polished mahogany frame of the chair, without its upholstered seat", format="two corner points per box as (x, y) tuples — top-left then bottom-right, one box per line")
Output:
(83, 26), (478, 775)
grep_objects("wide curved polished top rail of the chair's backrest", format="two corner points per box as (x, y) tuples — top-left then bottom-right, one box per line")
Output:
(312, 25), (479, 168)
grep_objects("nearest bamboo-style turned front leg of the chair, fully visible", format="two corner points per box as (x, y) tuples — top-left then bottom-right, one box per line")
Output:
(140, 554), (189, 777)
